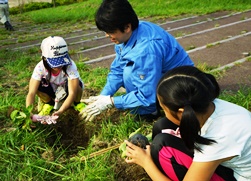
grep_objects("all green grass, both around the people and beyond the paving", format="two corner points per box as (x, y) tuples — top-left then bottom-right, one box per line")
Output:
(0, 0), (251, 181)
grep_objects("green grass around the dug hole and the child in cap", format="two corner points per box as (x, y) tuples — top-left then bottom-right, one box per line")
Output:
(0, 50), (146, 181)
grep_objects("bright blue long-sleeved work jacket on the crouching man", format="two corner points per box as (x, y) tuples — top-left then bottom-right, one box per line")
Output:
(101, 21), (194, 115)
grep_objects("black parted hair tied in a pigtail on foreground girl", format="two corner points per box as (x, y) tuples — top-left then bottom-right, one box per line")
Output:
(157, 66), (220, 151)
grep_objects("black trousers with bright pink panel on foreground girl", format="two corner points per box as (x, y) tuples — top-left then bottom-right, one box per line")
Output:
(151, 118), (236, 181)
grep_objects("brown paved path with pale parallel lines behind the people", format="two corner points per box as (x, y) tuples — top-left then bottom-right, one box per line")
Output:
(0, 10), (251, 91)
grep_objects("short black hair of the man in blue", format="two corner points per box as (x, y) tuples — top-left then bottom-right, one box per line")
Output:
(95, 0), (139, 33)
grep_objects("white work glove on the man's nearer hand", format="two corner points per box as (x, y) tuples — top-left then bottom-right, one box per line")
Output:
(79, 95), (113, 121)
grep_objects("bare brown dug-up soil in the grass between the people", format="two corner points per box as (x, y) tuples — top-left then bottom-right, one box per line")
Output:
(42, 89), (151, 181)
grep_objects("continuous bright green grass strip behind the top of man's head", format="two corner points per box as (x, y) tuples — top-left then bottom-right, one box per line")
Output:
(7, 0), (251, 24)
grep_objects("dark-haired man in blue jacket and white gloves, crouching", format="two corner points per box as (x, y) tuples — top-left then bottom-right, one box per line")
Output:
(80, 0), (194, 122)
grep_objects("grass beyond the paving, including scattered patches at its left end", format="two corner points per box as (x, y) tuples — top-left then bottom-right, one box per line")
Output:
(0, 0), (251, 42)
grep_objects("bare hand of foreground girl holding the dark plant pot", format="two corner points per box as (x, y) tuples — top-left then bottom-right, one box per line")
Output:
(125, 140), (152, 168)
